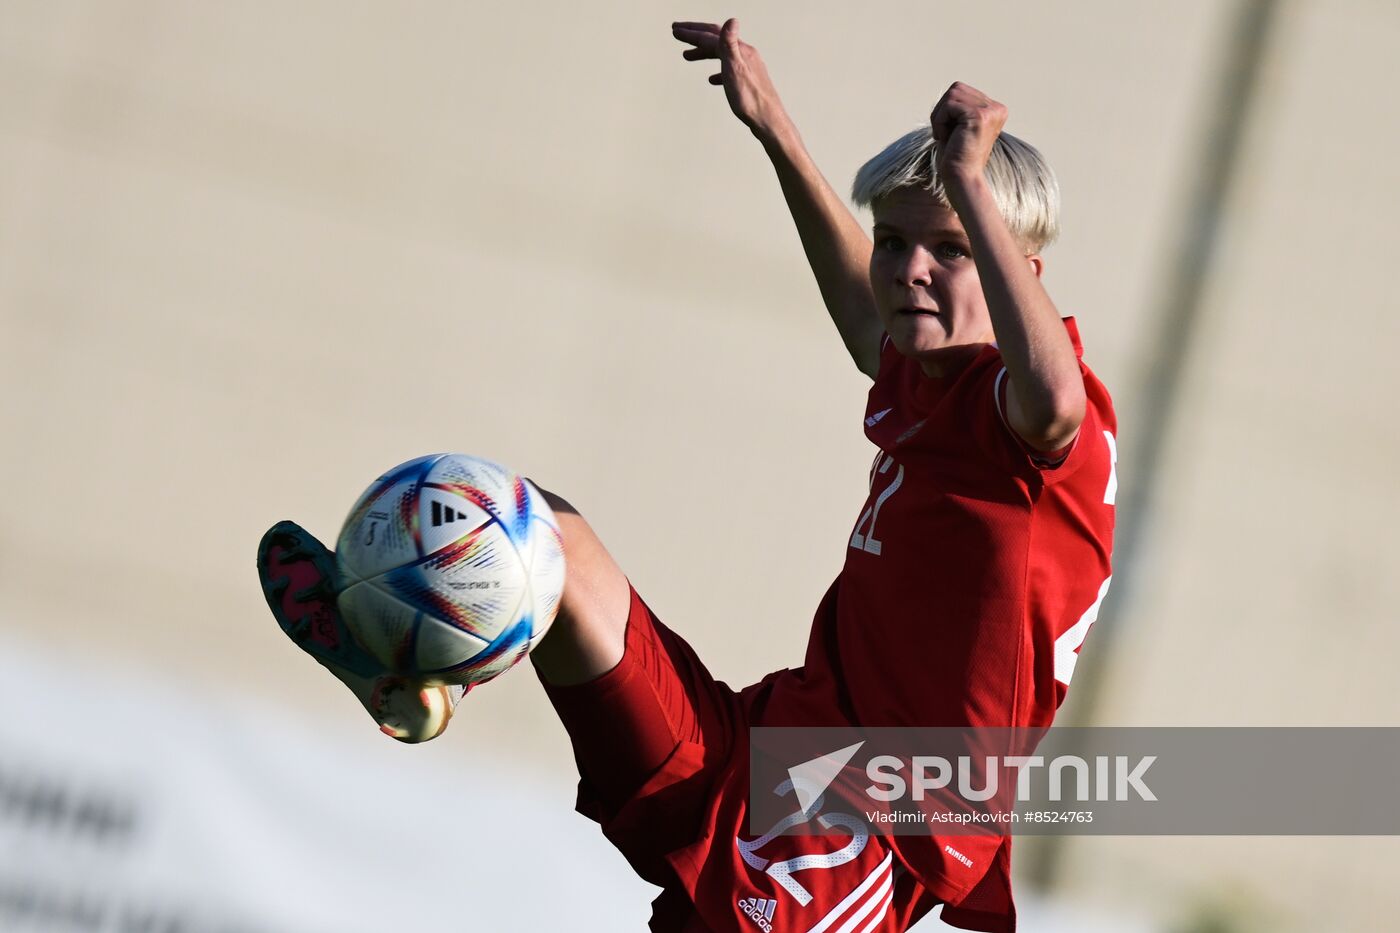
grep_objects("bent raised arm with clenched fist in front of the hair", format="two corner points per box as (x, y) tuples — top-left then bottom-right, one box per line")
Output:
(930, 84), (1085, 451)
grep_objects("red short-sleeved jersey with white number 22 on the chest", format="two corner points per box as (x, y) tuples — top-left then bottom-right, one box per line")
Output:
(745, 318), (1117, 930)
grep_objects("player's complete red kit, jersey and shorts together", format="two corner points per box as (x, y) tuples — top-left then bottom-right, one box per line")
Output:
(546, 319), (1116, 933)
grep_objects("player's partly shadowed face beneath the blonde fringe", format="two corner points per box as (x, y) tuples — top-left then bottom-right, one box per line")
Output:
(871, 188), (994, 375)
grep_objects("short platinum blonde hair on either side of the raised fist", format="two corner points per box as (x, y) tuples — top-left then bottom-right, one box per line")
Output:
(851, 123), (1060, 252)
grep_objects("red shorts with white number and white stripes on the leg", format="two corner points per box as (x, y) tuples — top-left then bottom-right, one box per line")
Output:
(534, 590), (938, 933)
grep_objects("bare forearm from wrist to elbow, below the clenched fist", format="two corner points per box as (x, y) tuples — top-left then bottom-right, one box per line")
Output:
(948, 177), (1085, 447)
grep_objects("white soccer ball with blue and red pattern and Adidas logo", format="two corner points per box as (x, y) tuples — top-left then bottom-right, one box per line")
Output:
(336, 454), (564, 684)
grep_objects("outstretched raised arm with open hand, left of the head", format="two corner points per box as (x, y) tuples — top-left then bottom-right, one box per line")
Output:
(671, 20), (883, 378)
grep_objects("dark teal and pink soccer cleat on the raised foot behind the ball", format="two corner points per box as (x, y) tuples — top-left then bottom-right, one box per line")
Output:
(258, 521), (470, 742)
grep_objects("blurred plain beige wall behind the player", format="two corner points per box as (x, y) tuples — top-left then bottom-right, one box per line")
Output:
(0, 0), (1400, 930)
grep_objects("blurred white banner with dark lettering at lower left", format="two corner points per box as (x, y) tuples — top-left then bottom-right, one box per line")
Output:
(0, 636), (655, 933)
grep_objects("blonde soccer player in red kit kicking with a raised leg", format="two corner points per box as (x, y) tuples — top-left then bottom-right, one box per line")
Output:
(258, 20), (1117, 933)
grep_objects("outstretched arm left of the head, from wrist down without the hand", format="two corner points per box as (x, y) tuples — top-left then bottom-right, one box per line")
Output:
(755, 120), (882, 378)
